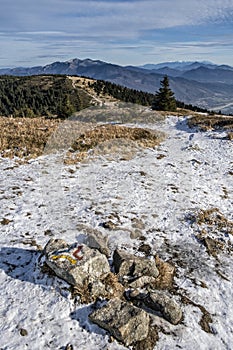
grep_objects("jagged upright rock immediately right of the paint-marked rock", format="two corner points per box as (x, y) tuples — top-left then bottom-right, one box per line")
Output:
(113, 249), (159, 282)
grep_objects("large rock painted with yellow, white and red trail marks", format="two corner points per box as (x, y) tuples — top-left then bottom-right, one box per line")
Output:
(44, 239), (110, 288)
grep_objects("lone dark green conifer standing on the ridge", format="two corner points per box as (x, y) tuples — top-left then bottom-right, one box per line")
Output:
(151, 76), (176, 112)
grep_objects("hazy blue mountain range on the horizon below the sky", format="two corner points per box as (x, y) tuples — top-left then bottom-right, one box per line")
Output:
(0, 58), (233, 113)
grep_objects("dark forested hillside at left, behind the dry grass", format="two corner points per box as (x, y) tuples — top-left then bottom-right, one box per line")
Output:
(0, 75), (90, 117)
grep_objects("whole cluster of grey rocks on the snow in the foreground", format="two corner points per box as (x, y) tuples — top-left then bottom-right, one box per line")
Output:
(43, 236), (183, 349)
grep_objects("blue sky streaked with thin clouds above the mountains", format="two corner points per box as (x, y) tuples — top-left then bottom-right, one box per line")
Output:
(0, 0), (233, 67)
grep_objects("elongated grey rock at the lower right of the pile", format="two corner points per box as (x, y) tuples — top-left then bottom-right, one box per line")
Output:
(129, 291), (183, 325)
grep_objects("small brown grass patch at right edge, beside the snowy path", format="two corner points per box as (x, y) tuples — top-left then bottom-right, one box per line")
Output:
(188, 115), (233, 131)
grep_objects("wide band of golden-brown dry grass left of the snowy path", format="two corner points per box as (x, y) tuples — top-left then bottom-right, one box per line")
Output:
(0, 117), (165, 164)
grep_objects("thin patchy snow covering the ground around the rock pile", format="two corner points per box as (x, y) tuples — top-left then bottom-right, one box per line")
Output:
(0, 117), (233, 350)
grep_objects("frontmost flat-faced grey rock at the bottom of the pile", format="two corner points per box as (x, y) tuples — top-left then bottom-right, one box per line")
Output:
(89, 298), (150, 346)
